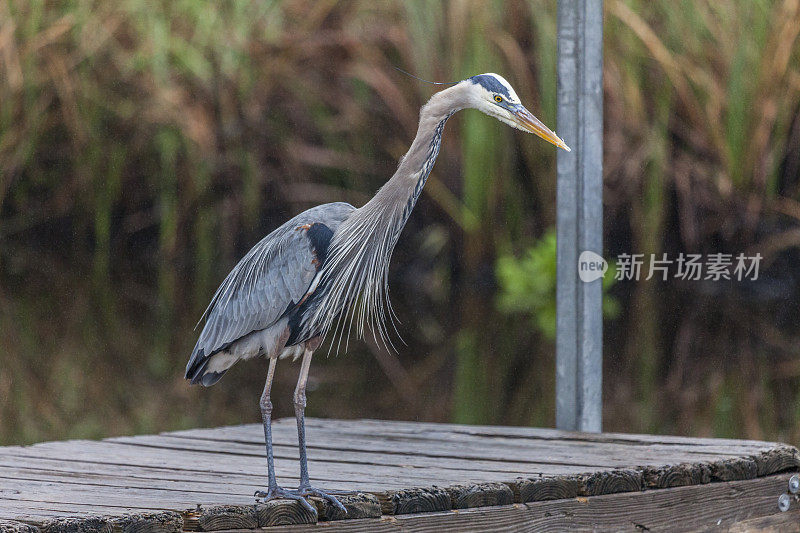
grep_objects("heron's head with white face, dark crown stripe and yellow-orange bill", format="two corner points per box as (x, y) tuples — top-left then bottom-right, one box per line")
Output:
(461, 73), (571, 152)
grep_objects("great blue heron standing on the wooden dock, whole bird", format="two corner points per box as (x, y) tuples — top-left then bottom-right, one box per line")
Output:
(186, 74), (569, 511)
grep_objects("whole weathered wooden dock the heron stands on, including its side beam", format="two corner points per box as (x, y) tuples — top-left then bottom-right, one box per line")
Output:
(0, 419), (800, 533)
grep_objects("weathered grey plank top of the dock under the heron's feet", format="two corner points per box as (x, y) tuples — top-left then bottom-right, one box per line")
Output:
(0, 420), (800, 533)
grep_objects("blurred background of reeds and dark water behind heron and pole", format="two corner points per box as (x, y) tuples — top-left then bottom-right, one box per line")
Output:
(0, 0), (800, 443)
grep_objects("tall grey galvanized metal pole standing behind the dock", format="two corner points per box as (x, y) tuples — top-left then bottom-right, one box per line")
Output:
(556, 0), (603, 431)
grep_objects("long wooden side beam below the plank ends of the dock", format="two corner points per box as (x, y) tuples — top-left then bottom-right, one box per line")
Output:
(205, 474), (800, 533)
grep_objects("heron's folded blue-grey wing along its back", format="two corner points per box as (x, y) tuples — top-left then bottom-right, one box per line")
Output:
(186, 202), (355, 378)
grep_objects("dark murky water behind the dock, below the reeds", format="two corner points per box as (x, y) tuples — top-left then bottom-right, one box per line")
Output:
(0, 208), (800, 444)
